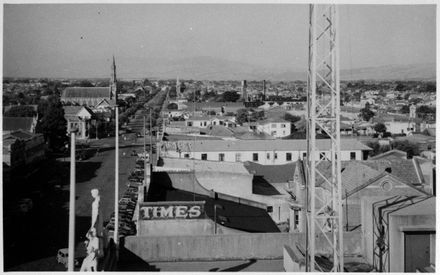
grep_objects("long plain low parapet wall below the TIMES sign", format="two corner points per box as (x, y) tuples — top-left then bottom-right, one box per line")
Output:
(125, 232), (363, 262)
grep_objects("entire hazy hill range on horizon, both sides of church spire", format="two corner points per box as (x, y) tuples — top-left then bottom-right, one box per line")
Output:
(5, 57), (436, 81)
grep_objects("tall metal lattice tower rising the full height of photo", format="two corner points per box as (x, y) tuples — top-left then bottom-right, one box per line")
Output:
(306, 4), (344, 272)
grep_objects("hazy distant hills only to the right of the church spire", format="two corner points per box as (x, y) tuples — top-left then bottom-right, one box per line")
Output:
(120, 57), (436, 81)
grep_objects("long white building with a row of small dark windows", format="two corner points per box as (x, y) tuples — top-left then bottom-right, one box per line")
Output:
(161, 139), (371, 165)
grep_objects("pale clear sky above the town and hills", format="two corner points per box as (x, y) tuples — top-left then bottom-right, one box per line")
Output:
(3, 4), (436, 77)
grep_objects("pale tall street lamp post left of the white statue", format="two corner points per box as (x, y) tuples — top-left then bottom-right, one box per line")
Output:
(67, 128), (78, 272)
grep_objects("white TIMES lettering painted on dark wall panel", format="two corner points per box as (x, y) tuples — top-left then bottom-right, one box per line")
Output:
(139, 201), (205, 220)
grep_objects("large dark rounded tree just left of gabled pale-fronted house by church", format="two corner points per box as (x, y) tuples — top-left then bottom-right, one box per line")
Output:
(36, 100), (67, 151)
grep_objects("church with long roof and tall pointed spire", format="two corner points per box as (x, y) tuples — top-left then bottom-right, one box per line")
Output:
(61, 56), (117, 109)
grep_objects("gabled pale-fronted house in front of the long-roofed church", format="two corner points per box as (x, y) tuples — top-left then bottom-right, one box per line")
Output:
(63, 106), (94, 139)
